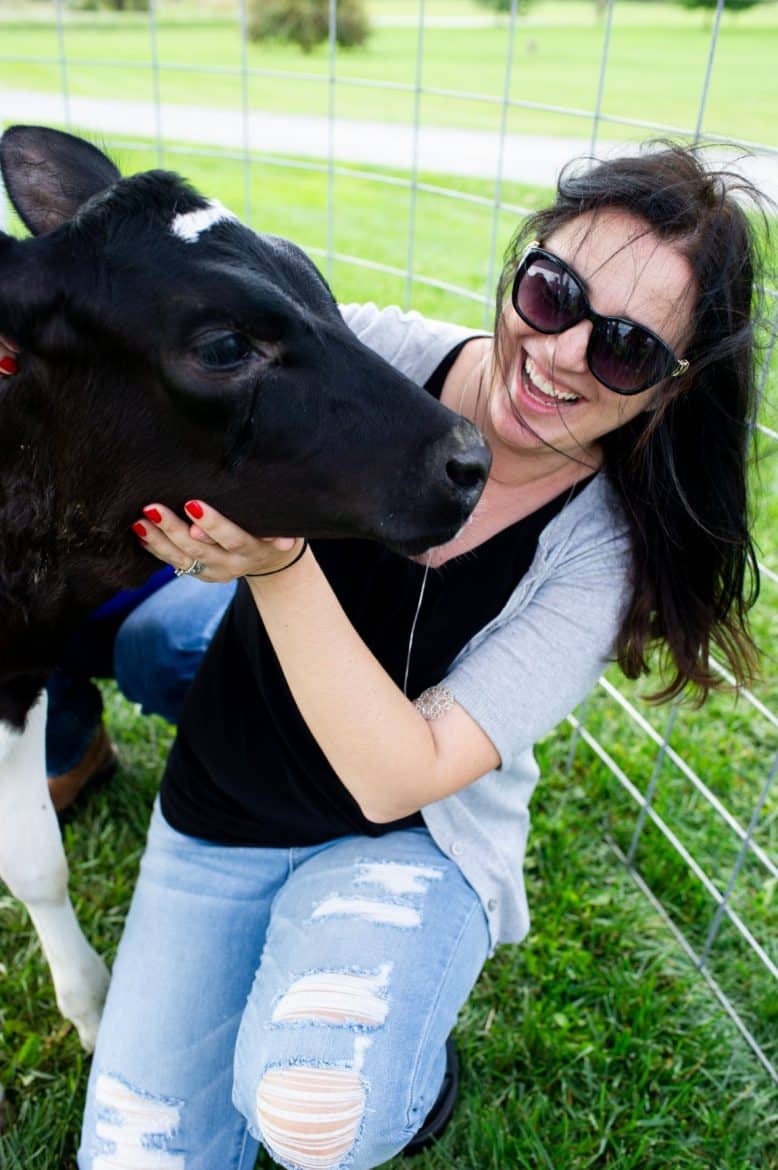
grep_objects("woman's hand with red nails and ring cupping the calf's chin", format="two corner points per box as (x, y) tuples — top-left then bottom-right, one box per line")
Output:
(132, 500), (302, 581)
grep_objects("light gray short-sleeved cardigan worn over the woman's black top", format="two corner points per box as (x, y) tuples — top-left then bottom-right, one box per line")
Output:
(342, 304), (629, 949)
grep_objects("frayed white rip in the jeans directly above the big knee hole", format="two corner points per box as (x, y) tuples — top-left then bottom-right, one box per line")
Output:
(273, 963), (391, 1027)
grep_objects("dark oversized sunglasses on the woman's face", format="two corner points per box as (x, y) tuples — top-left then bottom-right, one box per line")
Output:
(511, 241), (689, 394)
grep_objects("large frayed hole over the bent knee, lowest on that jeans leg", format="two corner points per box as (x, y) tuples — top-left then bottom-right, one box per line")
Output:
(256, 1066), (365, 1170)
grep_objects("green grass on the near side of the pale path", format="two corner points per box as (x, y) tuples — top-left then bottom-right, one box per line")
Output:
(0, 125), (778, 1170)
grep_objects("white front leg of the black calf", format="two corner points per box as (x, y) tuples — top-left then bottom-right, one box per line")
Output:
(0, 694), (108, 1051)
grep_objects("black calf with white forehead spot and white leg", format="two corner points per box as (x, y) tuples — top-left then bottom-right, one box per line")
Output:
(0, 126), (489, 1047)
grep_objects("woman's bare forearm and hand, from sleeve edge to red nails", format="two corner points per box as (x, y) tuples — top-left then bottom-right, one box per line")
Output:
(136, 504), (500, 823)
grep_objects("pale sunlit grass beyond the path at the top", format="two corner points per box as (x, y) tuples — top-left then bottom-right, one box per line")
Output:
(0, 0), (778, 144)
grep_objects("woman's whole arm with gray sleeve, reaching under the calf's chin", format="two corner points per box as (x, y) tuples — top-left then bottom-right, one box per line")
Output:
(135, 480), (632, 821)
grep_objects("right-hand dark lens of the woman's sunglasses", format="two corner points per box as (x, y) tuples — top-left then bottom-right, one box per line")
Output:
(588, 318), (672, 394)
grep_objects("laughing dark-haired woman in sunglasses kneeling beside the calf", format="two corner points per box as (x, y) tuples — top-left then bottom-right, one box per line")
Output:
(80, 149), (756, 1170)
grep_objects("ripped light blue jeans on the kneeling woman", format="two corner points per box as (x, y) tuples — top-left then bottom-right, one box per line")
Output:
(78, 808), (489, 1170)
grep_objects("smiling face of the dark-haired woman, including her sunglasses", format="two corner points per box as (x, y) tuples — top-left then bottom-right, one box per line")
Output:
(463, 212), (694, 475)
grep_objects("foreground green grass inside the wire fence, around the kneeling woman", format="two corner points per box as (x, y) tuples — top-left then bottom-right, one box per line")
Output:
(0, 711), (778, 1170)
